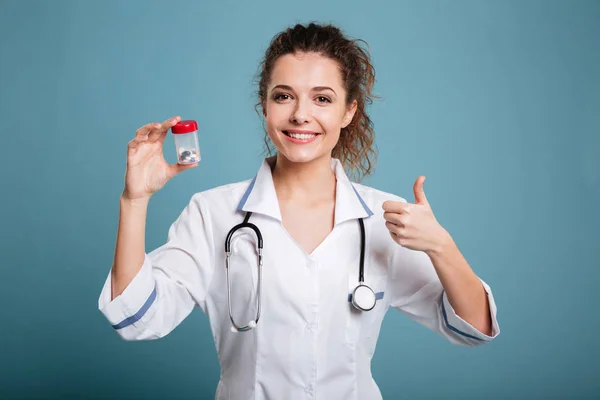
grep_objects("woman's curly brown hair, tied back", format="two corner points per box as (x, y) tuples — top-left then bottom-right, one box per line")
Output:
(256, 23), (377, 181)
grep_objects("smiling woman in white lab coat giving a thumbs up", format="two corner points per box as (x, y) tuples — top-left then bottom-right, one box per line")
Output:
(99, 24), (499, 399)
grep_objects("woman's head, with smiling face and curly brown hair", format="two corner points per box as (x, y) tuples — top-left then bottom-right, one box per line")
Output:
(257, 24), (376, 181)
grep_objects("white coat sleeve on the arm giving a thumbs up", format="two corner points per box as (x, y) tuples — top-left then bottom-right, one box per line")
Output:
(388, 246), (500, 346)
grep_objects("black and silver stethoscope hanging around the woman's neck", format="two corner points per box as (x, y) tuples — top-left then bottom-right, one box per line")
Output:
(225, 211), (377, 332)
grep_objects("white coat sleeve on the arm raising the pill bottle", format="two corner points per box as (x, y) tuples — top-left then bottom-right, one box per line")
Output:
(98, 194), (214, 340)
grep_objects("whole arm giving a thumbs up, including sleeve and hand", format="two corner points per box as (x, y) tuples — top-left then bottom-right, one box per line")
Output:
(382, 176), (500, 345)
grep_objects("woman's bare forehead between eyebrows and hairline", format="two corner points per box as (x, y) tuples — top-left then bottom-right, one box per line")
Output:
(269, 53), (343, 91)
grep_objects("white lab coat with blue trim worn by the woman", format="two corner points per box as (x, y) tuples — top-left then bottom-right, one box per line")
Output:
(99, 159), (500, 400)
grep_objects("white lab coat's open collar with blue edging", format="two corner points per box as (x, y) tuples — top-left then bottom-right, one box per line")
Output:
(237, 157), (373, 225)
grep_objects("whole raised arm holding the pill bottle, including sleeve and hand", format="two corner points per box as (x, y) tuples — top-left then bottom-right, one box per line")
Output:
(98, 117), (209, 340)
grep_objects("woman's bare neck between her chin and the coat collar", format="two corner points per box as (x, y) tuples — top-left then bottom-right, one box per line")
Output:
(273, 154), (336, 202)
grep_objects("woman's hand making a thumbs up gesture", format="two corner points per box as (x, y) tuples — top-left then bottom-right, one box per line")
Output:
(383, 176), (449, 253)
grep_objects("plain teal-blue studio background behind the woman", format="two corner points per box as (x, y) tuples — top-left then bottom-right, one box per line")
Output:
(0, 0), (600, 399)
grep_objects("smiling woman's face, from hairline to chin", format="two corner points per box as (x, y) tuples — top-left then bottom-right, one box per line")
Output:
(263, 53), (356, 163)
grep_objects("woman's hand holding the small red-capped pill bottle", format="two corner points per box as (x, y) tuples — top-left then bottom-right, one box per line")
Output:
(122, 116), (198, 201)
